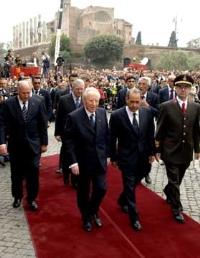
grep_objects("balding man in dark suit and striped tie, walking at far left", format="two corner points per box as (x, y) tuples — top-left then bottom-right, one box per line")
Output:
(0, 81), (48, 211)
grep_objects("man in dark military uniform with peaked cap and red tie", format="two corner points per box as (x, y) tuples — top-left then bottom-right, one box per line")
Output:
(156, 74), (200, 223)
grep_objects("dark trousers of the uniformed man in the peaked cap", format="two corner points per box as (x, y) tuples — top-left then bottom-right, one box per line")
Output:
(164, 162), (190, 215)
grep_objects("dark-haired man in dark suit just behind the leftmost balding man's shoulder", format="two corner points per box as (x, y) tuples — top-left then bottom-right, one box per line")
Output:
(32, 75), (53, 126)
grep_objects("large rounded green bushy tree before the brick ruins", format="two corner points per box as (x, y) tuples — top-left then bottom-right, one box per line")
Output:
(84, 35), (124, 63)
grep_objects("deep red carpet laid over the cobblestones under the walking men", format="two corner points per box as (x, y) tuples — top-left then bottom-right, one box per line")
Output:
(25, 155), (200, 258)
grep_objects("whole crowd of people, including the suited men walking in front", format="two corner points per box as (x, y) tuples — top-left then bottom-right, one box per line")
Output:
(0, 56), (200, 232)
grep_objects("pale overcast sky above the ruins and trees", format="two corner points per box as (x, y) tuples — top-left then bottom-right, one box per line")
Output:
(0, 0), (200, 47)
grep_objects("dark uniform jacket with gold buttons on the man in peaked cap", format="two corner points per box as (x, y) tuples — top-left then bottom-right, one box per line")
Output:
(155, 99), (200, 164)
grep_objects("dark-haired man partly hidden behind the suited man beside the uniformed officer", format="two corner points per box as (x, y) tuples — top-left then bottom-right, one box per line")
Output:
(116, 76), (135, 109)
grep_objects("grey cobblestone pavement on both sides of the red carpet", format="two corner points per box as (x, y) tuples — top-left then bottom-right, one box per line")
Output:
(0, 120), (200, 258)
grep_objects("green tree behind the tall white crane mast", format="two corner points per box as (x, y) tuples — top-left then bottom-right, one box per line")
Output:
(48, 34), (70, 61)
